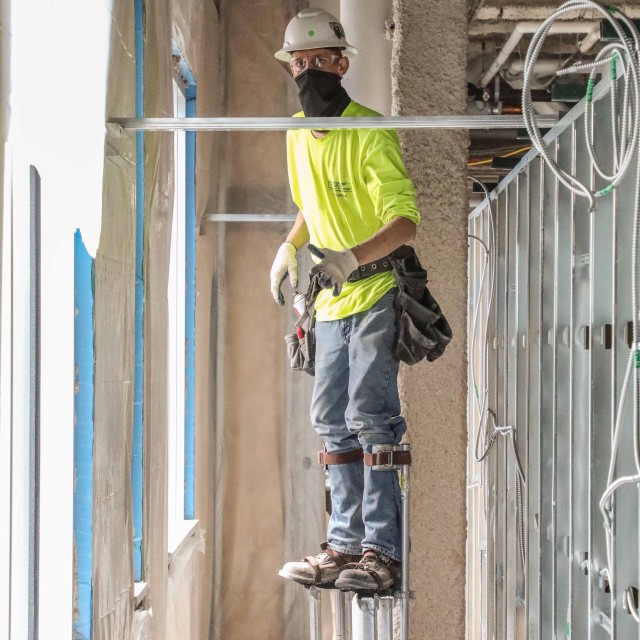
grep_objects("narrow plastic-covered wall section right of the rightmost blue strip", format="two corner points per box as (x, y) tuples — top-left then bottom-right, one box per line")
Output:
(167, 0), (222, 640)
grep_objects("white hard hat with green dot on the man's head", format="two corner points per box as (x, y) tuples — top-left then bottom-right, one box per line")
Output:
(274, 8), (358, 62)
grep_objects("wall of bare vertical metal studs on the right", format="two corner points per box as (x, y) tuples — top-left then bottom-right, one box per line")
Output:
(467, 77), (640, 640)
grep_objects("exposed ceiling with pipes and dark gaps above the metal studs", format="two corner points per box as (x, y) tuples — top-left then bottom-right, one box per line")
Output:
(467, 0), (640, 202)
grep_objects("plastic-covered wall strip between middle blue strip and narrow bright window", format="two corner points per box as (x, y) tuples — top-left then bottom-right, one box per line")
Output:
(142, 3), (175, 638)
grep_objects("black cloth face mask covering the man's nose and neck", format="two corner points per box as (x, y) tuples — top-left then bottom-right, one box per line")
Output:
(295, 69), (351, 118)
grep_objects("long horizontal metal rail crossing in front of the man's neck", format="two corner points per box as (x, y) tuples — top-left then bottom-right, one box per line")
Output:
(109, 116), (558, 131)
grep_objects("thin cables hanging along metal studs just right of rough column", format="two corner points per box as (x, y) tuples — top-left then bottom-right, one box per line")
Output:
(469, 176), (527, 576)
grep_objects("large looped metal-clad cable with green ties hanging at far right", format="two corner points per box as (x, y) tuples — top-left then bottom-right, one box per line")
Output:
(522, 0), (640, 624)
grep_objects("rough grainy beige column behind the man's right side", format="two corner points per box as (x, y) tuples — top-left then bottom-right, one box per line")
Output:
(392, 0), (468, 640)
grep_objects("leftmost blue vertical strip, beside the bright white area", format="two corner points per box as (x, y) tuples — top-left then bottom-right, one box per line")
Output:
(73, 230), (94, 640)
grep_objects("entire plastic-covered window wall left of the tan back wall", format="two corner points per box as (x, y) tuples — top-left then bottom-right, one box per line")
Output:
(93, 0), (220, 640)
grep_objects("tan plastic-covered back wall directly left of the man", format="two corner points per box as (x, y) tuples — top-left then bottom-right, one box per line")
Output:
(211, 0), (324, 640)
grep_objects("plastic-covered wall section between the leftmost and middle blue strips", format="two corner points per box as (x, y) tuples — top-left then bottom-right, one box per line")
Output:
(93, 0), (135, 640)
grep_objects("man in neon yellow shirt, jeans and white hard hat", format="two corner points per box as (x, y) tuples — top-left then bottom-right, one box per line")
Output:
(271, 8), (420, 591)
